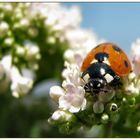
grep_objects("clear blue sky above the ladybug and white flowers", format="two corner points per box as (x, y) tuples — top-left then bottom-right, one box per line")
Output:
(64, 2), (140, 54)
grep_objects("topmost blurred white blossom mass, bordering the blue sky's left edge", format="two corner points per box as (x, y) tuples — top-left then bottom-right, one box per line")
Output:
(29, 3), (81, 31)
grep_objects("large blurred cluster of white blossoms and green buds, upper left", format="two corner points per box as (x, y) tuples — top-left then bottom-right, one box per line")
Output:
(0, 3), (84, 97)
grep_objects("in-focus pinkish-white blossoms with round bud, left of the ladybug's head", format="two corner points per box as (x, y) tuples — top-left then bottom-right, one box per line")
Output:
(50, 63), (86, 113)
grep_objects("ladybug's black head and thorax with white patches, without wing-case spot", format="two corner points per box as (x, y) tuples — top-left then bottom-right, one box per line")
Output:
(82, 62), (120, 93)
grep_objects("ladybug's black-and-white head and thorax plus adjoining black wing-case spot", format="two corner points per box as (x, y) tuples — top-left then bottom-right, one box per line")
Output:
(82, 50), (120, 93)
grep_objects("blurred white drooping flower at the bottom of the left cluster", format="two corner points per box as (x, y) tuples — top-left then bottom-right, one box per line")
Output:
(11, 66), (33, 98)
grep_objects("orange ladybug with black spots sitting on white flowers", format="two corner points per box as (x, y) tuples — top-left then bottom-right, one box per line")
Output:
(81, 43), (132, 94)
